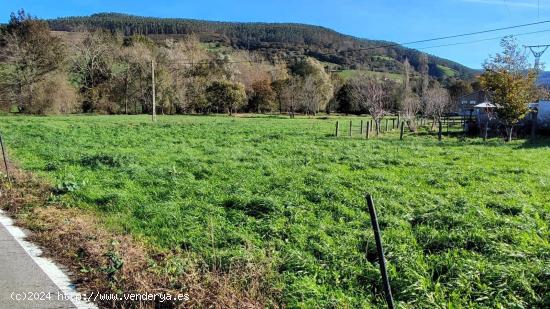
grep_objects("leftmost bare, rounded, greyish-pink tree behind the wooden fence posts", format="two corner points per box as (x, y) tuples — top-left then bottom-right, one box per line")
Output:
(351, 74), (390, 133)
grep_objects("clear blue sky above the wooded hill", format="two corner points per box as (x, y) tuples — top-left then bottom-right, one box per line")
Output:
(0, 0), (550, 68)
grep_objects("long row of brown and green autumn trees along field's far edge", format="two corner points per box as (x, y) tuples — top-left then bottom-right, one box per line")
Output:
(0, 11), (540, 142)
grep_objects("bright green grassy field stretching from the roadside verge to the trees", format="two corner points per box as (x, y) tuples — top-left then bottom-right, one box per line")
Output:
(0, 116), (550, 308)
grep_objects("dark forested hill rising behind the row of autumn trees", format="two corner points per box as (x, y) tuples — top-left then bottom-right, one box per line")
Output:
(48, 13), (475, 78)
